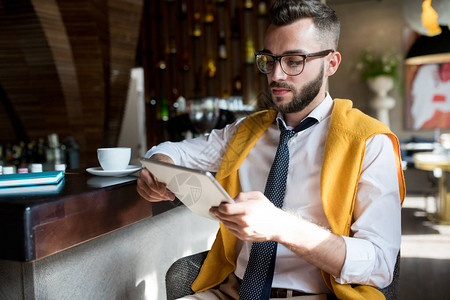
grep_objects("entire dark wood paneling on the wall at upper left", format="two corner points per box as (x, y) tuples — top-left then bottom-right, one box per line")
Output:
(0, 0), (143, 166)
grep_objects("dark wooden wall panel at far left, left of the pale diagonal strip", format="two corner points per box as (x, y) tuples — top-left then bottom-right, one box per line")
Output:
(0, 1), (58, 139)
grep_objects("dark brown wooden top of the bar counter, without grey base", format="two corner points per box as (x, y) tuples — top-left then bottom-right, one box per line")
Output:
(0, 170), (179, 262)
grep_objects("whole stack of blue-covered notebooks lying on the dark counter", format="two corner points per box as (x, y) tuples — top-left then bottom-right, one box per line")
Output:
(0, 171), (64, 195)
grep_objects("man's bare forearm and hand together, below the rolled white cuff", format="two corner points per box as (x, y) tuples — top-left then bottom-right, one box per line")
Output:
(210, 192), (346, 276)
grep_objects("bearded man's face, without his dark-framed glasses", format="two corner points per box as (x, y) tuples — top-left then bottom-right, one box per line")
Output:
(264, 19), (326, 113)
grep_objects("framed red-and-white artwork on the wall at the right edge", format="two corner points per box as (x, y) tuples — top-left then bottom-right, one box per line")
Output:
(404, 26), (450, 130)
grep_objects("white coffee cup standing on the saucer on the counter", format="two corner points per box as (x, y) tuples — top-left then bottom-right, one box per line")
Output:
(97, 147), (131, 171)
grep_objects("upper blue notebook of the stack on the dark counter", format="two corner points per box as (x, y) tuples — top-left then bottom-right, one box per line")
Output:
(0, 171), (64, 188)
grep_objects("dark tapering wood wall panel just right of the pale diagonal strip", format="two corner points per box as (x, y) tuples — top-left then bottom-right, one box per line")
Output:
(58, 0), (107, 164)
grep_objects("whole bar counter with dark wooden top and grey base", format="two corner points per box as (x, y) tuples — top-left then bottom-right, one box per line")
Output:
(0, 170), (218, 299)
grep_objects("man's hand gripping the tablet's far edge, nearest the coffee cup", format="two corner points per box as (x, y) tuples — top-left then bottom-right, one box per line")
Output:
(137, 154), (175, 202)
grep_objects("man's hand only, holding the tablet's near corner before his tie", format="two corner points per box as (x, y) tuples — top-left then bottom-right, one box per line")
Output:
(210, 192), (286, 242)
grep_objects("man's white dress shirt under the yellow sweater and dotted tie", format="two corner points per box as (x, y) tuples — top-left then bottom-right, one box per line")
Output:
(146, 94), (401, 293)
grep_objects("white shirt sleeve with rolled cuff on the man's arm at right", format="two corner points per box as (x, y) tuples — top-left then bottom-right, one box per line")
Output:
(335, 135), (401, 288)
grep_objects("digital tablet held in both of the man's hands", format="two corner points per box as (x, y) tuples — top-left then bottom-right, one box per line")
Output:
(140, 158), (234, 220)
